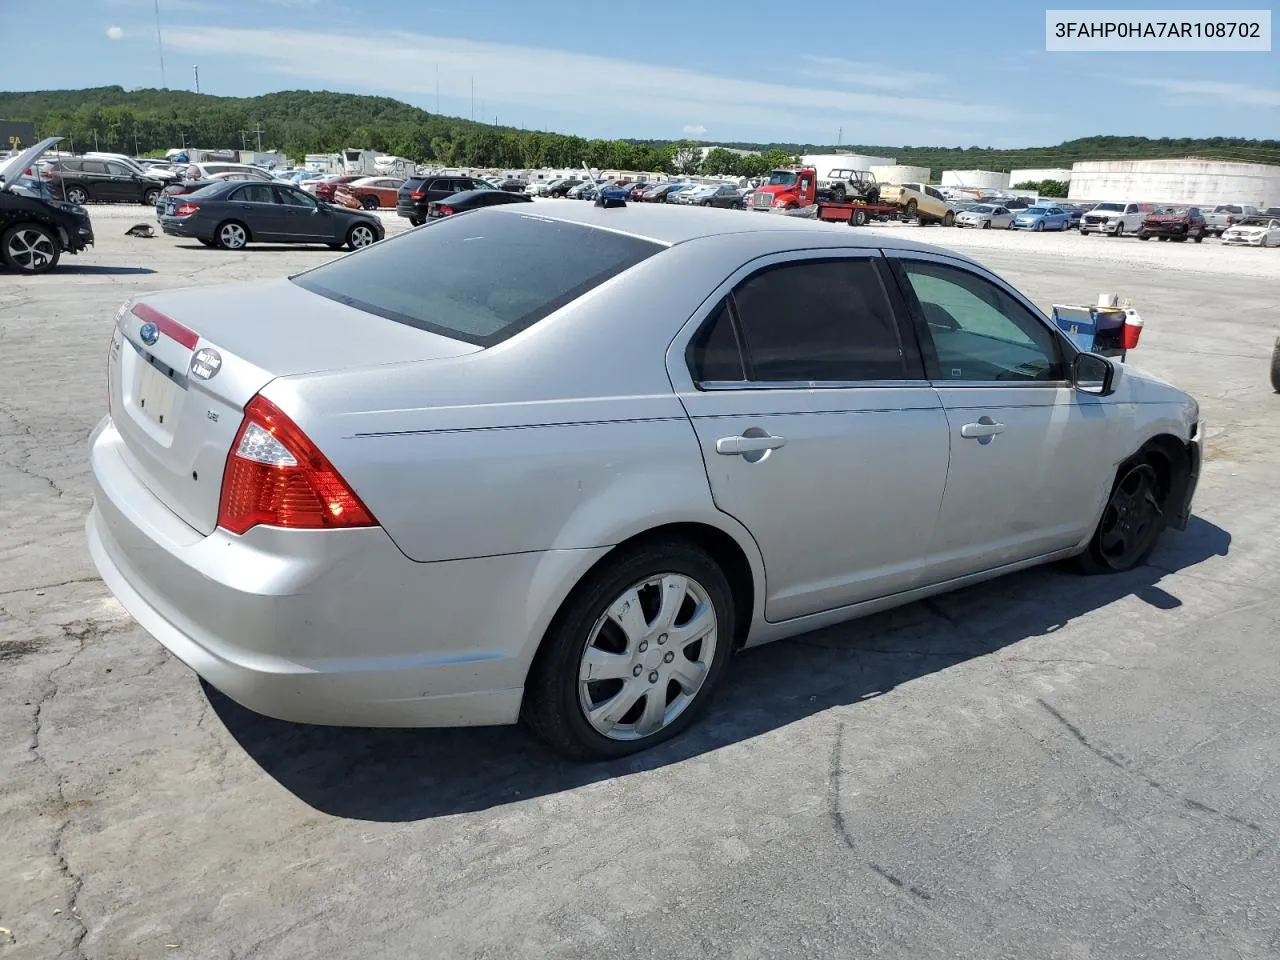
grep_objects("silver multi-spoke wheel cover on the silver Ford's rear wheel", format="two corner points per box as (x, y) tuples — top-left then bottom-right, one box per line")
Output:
(577, 573), (718, 740)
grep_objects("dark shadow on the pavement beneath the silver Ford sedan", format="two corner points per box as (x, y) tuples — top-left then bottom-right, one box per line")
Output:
(202, 517), (1231, 822)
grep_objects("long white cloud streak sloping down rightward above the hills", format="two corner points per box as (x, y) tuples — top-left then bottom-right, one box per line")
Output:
(165, 27), (1018, 143)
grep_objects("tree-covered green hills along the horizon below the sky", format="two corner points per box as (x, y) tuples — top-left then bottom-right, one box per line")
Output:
(0, 87), (1280, 178)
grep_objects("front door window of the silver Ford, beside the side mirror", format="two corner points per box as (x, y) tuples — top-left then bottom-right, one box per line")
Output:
(902, 260), (1064, 383)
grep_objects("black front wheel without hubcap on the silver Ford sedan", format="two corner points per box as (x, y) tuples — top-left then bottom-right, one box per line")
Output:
(1075, 453), (1176, 573)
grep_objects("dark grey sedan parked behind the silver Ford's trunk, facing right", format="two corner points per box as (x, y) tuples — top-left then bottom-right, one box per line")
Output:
(160, 180), (383, 250)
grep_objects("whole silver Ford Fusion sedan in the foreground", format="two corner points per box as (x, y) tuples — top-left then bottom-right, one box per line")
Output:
(87, 204), (1203, 758)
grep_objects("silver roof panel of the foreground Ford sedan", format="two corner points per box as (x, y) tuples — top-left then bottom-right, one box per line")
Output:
(490, 202), (968, 260)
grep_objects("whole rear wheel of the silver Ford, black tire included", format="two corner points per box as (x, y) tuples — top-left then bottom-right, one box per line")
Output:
(522, 540), (735, 760)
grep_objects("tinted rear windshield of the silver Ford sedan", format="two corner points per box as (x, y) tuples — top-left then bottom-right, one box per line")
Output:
(292, 209), (663, 347)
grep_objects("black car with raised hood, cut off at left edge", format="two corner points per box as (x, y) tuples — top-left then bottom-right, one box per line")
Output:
(0, 137), (93, 274)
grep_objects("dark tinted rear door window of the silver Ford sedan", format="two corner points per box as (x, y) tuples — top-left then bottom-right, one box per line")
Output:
(733, 260), (904, 381)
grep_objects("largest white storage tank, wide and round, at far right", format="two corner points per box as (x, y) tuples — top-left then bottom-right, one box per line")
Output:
(1068, 157), (1280, 207)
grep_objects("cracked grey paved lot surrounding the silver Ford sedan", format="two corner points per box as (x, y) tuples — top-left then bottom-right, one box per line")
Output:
(0, 201), (1280, 960)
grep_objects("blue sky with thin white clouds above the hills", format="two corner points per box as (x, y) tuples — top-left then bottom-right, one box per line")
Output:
(0, 0), (1280, 147)
